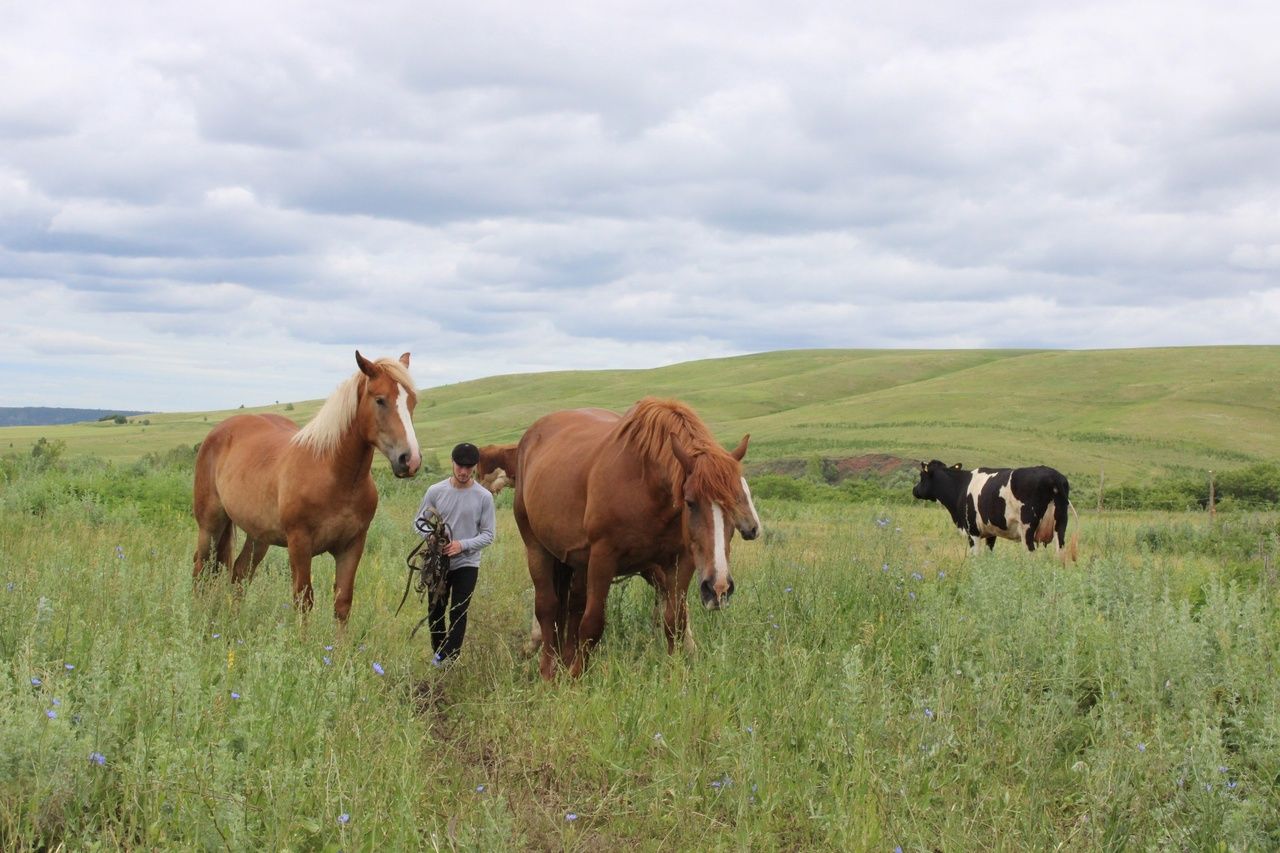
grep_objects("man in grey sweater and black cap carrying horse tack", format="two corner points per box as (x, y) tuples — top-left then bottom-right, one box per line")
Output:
(415, 442), (495, 666)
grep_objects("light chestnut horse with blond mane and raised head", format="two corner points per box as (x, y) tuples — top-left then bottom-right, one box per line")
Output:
(192, 351), (422, 622)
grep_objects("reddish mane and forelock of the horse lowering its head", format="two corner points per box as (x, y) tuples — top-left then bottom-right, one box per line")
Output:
(614, 397), (742, 506)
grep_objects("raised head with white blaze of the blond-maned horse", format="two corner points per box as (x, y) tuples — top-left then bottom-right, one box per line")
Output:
(356, 350), (422, 478)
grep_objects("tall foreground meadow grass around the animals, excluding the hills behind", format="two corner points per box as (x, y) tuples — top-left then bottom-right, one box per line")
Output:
(0, 450), (1280, 850)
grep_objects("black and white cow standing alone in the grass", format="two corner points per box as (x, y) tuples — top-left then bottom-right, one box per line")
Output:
(911, 460), (1079, 561)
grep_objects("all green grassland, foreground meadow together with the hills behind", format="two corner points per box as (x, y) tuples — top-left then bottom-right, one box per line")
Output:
(0, 347), (1280, 852)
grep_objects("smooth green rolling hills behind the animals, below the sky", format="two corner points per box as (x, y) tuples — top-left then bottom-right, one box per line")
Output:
(0, 347), (1280, 482)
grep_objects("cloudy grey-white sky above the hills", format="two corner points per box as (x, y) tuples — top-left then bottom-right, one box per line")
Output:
(0, 0), (1280, 411)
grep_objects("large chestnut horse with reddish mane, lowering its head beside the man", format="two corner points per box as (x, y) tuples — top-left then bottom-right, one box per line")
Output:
(515, 397), (760, 680)
